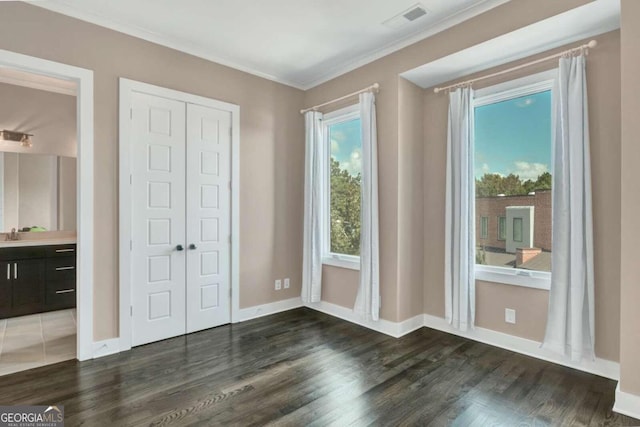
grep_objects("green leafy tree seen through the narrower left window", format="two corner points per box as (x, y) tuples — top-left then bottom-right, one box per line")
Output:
(331, 157), (362, 255)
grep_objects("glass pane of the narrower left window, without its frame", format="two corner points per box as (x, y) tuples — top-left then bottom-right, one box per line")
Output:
(328, 119), (362, 255)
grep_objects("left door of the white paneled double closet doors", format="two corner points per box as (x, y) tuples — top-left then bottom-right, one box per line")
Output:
(131, 93), (187, 345)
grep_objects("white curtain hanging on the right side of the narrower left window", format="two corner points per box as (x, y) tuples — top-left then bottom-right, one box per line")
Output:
(354, 92), (380, 320)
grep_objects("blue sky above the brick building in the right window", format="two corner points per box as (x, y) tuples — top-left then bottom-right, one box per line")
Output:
(475, 91), (551, 181)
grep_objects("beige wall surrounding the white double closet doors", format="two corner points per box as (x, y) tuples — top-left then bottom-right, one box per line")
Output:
(0, 2), (304, 340)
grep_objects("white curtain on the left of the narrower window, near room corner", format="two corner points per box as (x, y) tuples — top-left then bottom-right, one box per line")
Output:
(301, 111), (323, 303)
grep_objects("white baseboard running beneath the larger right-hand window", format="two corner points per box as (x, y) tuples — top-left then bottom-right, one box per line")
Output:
(424, 314), (620, 380)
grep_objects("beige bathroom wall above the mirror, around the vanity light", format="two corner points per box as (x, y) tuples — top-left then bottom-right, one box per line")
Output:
(0, 83), (77, 157)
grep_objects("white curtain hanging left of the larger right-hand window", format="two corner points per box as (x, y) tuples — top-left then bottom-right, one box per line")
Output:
(445, 87), (476, 331)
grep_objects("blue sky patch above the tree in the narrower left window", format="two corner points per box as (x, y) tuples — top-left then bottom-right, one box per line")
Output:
(329, 119), (362, 176)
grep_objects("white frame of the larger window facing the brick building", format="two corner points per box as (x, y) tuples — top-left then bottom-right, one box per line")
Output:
(471, 68), (558, 290)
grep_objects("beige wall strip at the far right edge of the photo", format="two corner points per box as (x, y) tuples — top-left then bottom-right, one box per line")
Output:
(618, 0), (640, 395)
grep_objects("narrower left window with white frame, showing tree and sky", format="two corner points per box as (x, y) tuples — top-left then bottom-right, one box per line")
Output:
(322, 105), (362, 269)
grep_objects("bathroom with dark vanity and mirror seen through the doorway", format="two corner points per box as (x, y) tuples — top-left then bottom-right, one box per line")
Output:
(0, 67), (78, 375)
